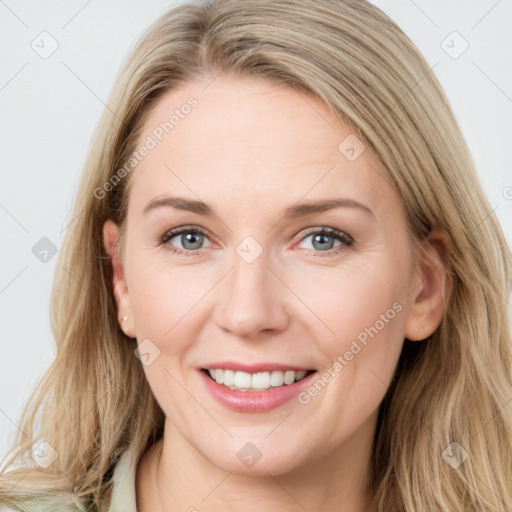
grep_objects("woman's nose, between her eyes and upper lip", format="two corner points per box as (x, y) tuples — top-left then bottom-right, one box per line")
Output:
(214, 248), (289, 339)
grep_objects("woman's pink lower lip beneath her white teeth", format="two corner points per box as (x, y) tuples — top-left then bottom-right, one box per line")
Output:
(199, 370), (316, 412)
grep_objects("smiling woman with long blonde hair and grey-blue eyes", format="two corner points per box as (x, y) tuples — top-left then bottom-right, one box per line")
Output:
(0, 0), (512, 512)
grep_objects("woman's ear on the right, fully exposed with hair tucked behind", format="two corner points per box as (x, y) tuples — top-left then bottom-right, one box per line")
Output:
(405, 228), (452, 341)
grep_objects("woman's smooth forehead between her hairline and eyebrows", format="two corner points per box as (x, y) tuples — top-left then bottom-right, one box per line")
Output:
(130, 76), (398, 218)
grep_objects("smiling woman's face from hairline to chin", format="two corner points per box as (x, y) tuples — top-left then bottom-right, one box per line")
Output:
(105, 76), (434, 474)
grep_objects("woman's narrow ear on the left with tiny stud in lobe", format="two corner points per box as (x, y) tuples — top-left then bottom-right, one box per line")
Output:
(103, 219), (135, 337)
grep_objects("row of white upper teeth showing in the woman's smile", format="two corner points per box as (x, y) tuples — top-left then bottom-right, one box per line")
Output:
(208, 368), (307, 391)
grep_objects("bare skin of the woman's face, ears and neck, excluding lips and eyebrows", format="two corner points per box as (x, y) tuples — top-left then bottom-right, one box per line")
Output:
(103, 75), (446, 512)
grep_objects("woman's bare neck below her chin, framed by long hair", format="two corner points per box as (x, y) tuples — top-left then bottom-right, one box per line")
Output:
(136, 416), (376, 512)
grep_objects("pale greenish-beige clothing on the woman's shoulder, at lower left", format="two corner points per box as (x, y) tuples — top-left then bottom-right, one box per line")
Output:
(0, 449), (137, 512)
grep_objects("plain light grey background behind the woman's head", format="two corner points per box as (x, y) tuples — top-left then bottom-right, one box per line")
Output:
(0, 0), (512, 460)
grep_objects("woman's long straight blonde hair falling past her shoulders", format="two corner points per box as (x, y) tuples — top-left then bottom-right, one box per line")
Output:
(0, 0), (512, 512)
